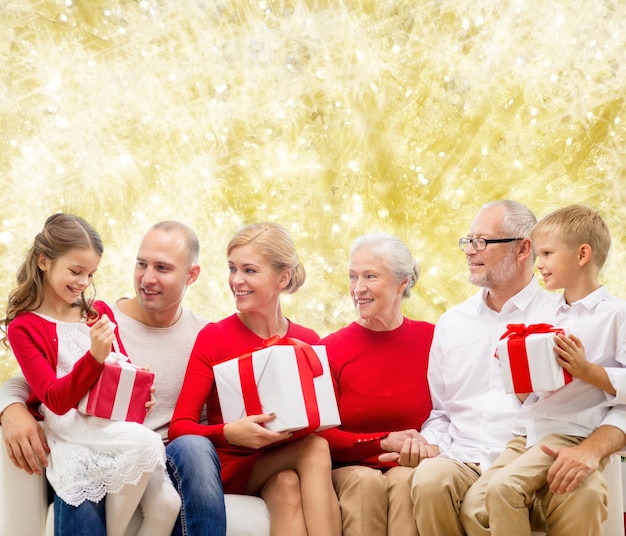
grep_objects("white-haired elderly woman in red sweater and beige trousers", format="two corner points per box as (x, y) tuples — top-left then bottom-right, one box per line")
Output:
(321, 233), (434, 536)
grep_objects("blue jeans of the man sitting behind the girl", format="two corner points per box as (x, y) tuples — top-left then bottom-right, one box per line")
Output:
(54, 435), (226, 536)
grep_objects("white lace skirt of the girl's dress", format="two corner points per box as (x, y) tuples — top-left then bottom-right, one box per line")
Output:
(41, 406), (168, 506)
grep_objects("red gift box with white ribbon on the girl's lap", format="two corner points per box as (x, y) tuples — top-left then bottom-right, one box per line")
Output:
(78, 352), (154, 423)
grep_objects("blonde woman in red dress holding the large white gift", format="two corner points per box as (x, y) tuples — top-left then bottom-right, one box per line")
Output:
(169, 223), (341, 536)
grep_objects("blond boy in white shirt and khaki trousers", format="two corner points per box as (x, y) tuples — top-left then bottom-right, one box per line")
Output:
(462, 205), (626, 536)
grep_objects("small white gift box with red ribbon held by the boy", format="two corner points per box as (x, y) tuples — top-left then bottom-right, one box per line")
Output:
(496, 324), (572, 393)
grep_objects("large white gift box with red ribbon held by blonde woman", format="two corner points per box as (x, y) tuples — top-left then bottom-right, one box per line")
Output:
(213, 337), (341, 432)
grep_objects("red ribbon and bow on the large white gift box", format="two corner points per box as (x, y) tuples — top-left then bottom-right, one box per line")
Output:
(238, 335), (323, 430)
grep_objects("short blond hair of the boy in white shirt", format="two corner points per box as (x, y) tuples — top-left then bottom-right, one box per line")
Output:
(530, 205), (611, 269)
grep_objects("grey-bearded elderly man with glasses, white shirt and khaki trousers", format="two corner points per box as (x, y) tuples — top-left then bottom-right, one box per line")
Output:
(400, 200), (626, 536)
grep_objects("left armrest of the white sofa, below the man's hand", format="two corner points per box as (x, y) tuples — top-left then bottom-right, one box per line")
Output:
(0, 426), (48, 536)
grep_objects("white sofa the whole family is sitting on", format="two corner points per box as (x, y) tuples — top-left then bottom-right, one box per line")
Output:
(0, 427), (624, 536)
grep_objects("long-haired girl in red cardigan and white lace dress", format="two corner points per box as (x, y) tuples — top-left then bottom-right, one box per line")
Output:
(2, 214), (180, 536)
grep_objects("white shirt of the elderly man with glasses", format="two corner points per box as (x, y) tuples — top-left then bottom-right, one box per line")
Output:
(421, 278), (560, 471)
